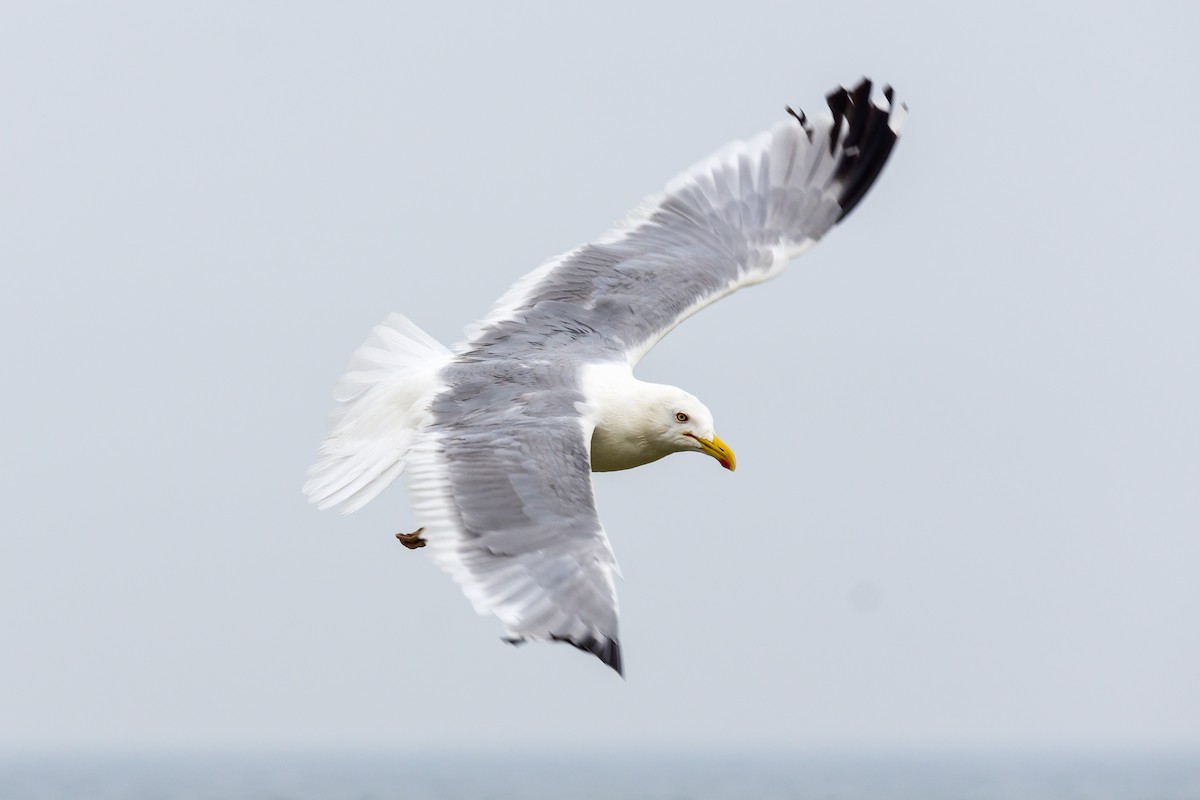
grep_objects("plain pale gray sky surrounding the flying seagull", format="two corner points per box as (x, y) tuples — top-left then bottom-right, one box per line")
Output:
(0, 2), (1200, 752)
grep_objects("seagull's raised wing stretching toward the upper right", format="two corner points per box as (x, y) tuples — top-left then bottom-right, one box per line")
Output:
(460, 79), (905, 363)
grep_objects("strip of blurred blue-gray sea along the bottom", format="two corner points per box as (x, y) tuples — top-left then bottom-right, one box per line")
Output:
(0, 754), (1200, 800)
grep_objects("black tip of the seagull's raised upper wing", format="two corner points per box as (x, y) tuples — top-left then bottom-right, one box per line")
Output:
(826, 77), (907, 222)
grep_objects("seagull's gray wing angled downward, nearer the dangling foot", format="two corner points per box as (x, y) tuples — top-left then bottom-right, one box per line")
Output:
(409, 359), (622, 673)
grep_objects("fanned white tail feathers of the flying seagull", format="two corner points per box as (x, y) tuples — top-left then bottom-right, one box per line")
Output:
(304, 314), (451, 513)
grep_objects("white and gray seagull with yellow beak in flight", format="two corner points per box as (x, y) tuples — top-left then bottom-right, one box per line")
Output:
(304, 78), (907, 675)
